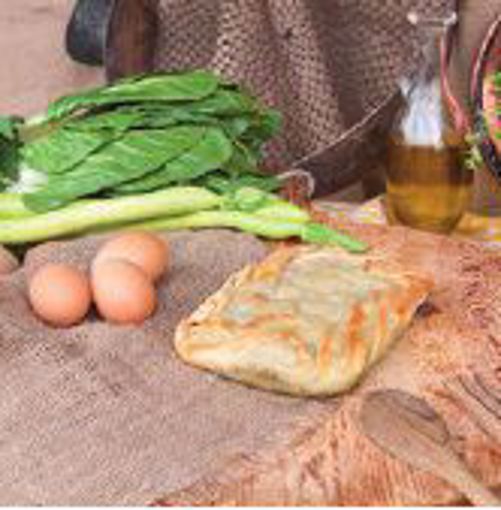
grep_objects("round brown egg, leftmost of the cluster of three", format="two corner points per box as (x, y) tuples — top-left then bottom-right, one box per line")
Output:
(29, 264), (91, 327)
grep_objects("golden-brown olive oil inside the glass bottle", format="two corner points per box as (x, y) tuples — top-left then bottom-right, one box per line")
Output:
(386, 137), (473, 233)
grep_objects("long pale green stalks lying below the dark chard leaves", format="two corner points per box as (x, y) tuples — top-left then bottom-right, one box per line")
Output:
(0, 187), (367, 253)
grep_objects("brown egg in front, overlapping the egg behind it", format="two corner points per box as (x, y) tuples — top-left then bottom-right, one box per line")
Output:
(92, 259), (157, 324)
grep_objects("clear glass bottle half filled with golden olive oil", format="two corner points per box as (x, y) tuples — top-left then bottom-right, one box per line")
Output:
(386, 14), (473, 233)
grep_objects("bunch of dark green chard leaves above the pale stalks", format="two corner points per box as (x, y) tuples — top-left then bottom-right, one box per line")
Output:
(0, 71), (280, 213)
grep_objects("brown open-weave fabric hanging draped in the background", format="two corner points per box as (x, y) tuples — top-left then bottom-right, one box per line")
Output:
(148, 0), (455, 193)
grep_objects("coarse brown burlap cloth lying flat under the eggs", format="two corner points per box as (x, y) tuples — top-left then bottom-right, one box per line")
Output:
(0, 232), (334, 505)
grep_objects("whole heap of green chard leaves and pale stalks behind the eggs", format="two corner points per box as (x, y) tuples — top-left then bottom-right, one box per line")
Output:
(0, 71), (365, 252)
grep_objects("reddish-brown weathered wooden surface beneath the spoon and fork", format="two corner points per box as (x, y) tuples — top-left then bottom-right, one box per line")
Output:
(154, 223), (501, 505)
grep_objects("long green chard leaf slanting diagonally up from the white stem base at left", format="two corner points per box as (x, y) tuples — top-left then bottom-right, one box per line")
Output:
(23, 126), (205, 212)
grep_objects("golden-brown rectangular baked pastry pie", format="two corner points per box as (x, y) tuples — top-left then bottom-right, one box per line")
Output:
(174, 246), (432, 395)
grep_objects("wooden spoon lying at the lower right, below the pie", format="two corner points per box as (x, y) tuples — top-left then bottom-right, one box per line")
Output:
(360, 390), (501, 506)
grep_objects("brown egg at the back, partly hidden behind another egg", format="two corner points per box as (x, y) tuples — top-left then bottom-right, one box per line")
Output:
(94, 231), (169, 281)
